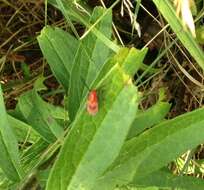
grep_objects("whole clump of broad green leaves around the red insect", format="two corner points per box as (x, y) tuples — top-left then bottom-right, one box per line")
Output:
(0, 0), (204, 190)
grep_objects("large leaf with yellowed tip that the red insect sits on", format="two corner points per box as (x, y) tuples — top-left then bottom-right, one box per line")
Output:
(47, 59), (138, 190)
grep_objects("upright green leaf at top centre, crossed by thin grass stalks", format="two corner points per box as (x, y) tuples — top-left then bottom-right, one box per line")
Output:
(82, 7), (112, 85)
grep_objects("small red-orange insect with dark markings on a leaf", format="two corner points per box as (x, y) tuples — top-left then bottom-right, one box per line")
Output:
(86, 90), (98, 115)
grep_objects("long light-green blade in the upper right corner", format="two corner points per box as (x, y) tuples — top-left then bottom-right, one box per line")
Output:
(153, 0), (204, 70)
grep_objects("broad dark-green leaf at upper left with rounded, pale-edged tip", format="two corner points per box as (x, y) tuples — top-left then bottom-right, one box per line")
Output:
(37, 26), (78, 91)
